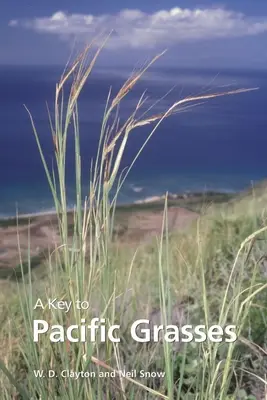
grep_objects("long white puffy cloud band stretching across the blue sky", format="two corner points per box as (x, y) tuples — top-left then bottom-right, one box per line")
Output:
(9, 7), (267, 48)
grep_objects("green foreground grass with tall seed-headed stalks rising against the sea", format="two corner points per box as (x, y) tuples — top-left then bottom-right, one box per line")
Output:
(0, 41), (267, 400)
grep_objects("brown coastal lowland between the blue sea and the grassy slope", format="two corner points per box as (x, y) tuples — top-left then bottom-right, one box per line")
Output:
(0, 192), (222, 279)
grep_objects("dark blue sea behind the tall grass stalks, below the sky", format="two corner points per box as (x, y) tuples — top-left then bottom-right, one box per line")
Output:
(0, 66), (267, 216)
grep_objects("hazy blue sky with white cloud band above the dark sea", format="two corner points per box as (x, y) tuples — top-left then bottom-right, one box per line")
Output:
(0, 0), (267, 69)
